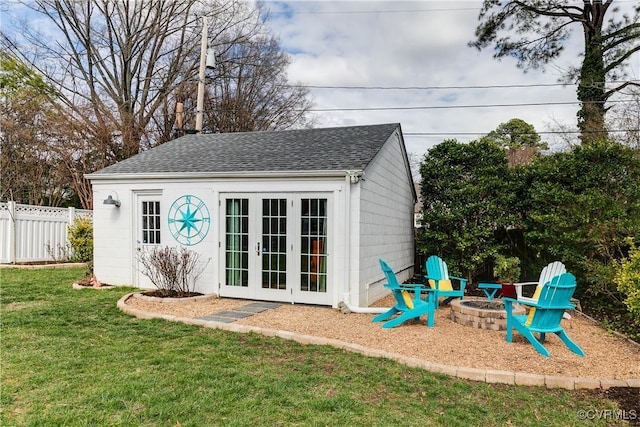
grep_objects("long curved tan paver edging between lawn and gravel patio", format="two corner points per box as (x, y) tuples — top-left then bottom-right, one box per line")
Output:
(117, 292), (640, 390)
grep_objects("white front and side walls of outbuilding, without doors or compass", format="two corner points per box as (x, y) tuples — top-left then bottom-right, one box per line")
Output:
(92, 139), (414, 307)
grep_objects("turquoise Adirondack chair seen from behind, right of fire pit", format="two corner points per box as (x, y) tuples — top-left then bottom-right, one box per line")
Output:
(502, 273), (584, 357)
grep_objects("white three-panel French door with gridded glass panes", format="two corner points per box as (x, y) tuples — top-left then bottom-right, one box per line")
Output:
(219, 193), (331, 304)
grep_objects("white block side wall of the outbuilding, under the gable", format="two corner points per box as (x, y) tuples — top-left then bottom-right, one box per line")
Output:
(354, 135), (415, 306)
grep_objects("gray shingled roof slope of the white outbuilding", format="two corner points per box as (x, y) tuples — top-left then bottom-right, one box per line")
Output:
(95, 123), (400, 175)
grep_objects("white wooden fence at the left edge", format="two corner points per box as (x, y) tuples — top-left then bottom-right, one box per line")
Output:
(0, 202), (93, 264)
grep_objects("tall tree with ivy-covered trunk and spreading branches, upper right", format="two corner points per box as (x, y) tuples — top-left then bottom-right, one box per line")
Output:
(469, 0), (640, 143)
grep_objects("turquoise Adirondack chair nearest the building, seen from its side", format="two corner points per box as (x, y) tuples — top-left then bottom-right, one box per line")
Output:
(373, 260), (435, 329)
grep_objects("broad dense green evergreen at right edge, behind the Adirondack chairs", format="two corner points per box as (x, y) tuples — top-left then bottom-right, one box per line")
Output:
(525, 140), (640, 300)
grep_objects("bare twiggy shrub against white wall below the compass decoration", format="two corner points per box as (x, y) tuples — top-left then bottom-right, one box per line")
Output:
(139, 246), (209, 297)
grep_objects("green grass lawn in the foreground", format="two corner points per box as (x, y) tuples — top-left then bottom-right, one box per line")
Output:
(0, 269), (628, 426)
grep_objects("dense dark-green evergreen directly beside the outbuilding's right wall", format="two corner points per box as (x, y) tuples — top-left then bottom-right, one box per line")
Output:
(418, 140), (513, 279)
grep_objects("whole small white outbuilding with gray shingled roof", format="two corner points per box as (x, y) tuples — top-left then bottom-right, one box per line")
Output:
(87, 123), (416, 307)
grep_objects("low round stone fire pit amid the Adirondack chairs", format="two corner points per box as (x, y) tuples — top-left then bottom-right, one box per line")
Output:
(451, 299), (526, 331)
